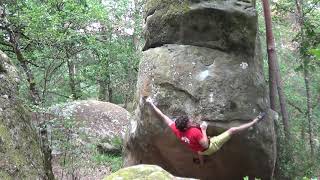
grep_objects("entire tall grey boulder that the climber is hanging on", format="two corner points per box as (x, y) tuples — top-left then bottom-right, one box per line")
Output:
(125, 0), (276, 179)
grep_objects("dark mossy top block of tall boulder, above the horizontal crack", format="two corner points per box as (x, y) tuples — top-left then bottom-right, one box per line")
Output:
(144, 0), (257, 54)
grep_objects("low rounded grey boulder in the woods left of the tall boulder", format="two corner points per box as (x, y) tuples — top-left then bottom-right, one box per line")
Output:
(50, 100), (130, 139)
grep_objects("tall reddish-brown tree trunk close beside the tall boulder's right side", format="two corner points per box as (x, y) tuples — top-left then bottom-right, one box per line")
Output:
(262, 0), (290, 140)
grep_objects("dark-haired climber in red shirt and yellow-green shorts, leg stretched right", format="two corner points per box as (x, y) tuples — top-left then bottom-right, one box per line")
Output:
(146, 97), (265, 165)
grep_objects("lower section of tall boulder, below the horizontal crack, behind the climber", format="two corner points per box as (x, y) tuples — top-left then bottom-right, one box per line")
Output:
(125, 45), (275, 179)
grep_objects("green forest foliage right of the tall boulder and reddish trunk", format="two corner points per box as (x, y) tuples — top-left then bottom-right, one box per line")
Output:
(257, 0), (320, 179)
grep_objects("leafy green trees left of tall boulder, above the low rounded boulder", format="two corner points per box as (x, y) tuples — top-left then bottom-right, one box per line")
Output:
(0, 0), (142, 106)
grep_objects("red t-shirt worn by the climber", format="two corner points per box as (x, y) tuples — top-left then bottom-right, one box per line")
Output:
(170, 123), (205, 152)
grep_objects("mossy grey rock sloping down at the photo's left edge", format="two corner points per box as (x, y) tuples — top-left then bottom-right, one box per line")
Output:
(0, 51), (52, 179)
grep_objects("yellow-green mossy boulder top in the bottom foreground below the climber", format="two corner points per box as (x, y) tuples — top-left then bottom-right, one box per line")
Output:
(104, 164), (198, 180)
